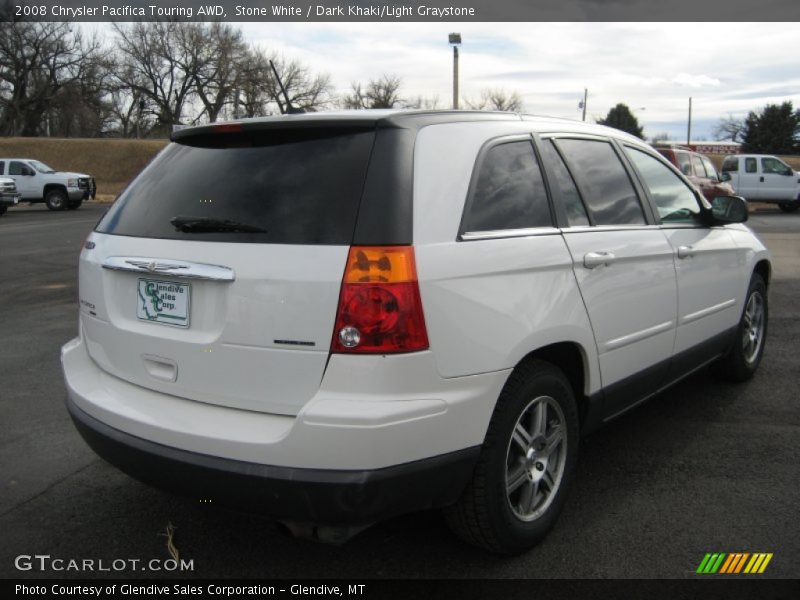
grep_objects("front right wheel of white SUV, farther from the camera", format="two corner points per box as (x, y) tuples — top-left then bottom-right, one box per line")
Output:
(714, 273), (769, 381)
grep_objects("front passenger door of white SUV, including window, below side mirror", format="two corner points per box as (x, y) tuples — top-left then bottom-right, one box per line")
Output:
(625, 145), (743, 379)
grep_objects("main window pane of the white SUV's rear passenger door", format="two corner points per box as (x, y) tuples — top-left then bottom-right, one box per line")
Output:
(558, 139), (645, 225)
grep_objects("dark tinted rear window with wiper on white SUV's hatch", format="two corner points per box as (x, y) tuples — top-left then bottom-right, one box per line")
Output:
(97, 130), (375, 245)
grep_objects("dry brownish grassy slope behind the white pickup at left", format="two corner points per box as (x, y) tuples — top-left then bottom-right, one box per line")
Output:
(0, 138), (167, 199)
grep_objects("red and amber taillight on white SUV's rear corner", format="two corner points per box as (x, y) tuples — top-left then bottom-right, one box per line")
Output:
(331, 246), (428, 354)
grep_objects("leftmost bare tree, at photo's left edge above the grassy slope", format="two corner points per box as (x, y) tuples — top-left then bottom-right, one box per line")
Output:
(0, 21), (99, 136)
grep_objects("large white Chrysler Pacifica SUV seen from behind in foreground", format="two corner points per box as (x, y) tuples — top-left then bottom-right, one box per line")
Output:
(62, 111), (770, 553)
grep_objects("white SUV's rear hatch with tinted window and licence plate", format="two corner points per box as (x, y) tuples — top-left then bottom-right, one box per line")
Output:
(80, 124), (375, 415)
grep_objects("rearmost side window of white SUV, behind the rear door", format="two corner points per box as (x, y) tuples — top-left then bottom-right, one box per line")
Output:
(462, 141), (553, 232)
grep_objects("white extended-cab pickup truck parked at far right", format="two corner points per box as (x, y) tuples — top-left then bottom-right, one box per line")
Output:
(722, 154), (800, 212)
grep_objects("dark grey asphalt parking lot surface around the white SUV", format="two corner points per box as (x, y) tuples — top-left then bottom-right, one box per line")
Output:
(0, 204), (800, 579)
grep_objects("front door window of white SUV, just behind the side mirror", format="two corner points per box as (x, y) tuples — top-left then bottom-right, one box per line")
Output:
(625, 146), (700, 223)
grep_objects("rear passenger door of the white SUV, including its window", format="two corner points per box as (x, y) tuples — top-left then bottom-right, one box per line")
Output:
(541, 136), (677, 418)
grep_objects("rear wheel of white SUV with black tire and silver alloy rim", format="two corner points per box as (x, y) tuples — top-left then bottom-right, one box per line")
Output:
(444, 360), (579, 554)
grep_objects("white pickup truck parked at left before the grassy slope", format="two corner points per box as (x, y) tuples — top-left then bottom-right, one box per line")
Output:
(0, 158), (97, 210)
